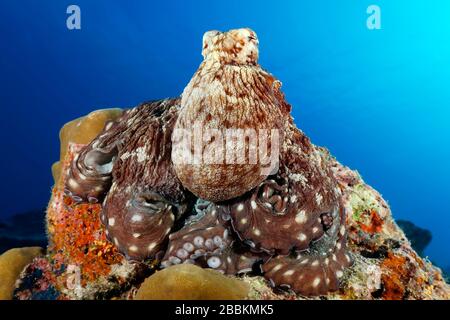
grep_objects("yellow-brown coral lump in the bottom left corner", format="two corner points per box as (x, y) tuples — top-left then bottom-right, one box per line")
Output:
(0, 247), (42, 300)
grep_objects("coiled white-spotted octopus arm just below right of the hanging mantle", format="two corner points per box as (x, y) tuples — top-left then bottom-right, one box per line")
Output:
(230, 172), (324, 254)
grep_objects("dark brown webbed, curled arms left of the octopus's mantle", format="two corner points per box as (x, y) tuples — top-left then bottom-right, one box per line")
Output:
(66, 99), (188, 260)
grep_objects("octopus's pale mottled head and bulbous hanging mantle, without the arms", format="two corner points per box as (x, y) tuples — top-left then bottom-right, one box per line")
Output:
(173, 29), (283, 202)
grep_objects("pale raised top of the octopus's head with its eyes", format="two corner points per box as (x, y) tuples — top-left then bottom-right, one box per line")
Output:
(202, 28), (259, 65)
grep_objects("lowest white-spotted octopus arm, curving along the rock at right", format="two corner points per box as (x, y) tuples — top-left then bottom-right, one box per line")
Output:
(262, 207), (353, 296)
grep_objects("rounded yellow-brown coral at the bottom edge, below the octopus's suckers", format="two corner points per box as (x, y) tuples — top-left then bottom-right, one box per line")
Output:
(135, 264), (250, 300)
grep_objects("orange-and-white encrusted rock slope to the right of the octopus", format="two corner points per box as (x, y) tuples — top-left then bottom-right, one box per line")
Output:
(330, 162), (450, 299)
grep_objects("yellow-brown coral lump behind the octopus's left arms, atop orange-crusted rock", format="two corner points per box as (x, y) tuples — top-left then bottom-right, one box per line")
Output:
(52, 108), (122, 182)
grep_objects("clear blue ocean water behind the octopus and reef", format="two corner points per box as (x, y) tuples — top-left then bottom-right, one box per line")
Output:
(0, 0), (450, 266)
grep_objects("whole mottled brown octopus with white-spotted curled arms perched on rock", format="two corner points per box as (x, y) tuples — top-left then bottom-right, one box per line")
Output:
(66, 29), (352, 296)
